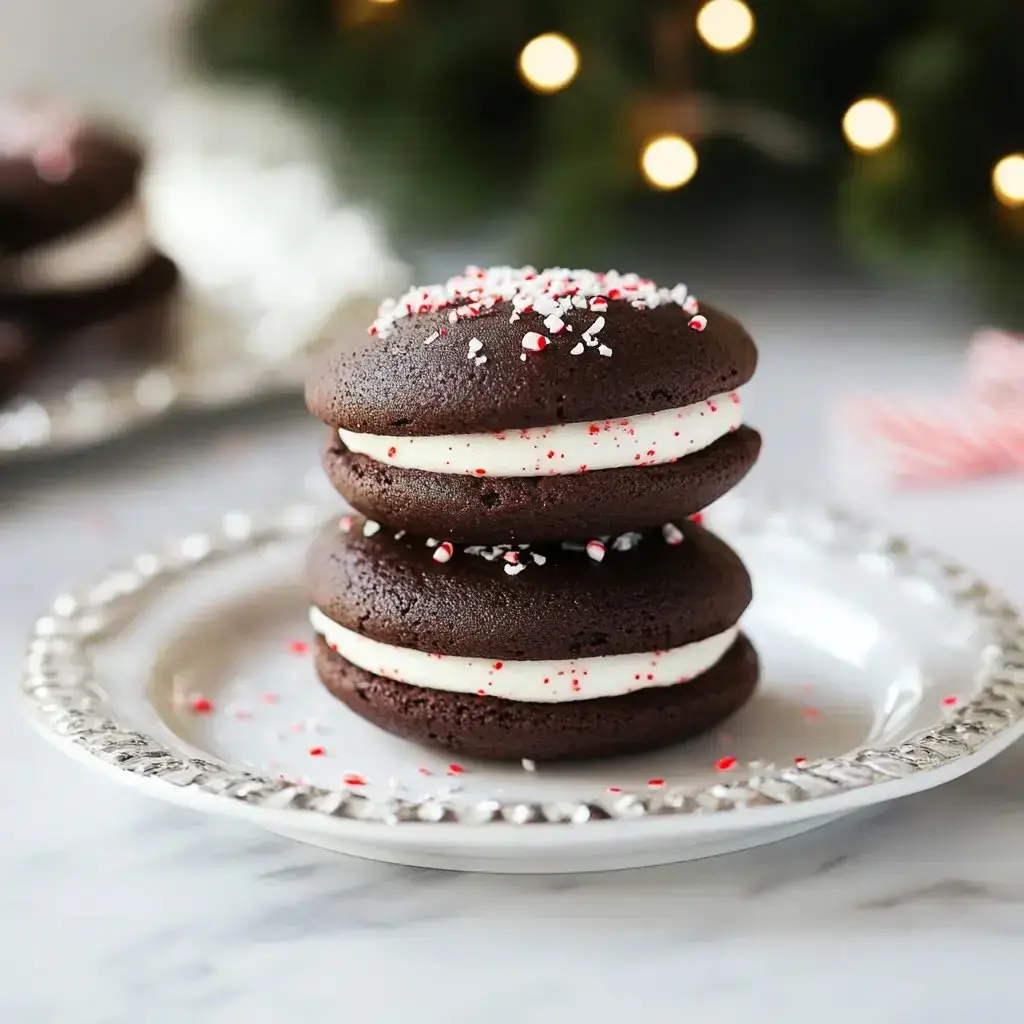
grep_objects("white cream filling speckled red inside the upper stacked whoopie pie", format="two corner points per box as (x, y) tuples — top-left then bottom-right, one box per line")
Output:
(338, 391), (743, 476)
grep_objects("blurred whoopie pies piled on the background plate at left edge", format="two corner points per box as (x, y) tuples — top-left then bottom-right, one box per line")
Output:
(0, 102), (178, 399)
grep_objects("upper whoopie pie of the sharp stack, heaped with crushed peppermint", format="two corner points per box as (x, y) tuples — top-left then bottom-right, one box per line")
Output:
(306, 267), (761, 543)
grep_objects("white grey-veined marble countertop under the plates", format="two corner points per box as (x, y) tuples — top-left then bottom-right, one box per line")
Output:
(0, 282), (1024, 1024)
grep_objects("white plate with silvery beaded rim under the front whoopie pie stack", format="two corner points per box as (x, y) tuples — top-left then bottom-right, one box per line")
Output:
(24, 499), (1024, 872)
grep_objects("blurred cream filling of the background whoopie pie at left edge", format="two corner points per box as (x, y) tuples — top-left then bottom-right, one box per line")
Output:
(0, 201), (153, 292)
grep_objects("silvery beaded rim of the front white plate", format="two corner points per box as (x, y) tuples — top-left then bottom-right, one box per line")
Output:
(22, 499), (1024, 825)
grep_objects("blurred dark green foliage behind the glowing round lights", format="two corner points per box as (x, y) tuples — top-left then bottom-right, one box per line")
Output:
(194, 0), (1024, 315)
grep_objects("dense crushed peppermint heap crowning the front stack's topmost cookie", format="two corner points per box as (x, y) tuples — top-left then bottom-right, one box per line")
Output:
(369, 266), (703, 337)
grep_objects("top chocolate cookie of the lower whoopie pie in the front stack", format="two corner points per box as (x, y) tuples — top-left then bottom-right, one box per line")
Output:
(307, 516), (751, 660)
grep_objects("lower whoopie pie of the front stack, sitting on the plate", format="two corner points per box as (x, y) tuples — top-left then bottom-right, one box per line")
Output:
(307, 517), (758, 761)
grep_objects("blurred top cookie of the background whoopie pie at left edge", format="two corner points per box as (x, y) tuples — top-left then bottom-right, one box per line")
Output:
(0, 103), (142, 257)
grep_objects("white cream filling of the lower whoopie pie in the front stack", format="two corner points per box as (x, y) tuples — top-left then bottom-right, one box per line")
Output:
(309, 607), (739, 703)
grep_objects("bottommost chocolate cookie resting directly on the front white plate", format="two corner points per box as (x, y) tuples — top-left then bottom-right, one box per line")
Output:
(316, 634), (758, 761)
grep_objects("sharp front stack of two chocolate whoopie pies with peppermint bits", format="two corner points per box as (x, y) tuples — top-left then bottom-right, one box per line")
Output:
(306, 267), (761, 760)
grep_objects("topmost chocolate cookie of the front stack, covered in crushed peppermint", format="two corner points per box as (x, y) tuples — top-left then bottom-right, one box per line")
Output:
(306, 267), (757, 436)
